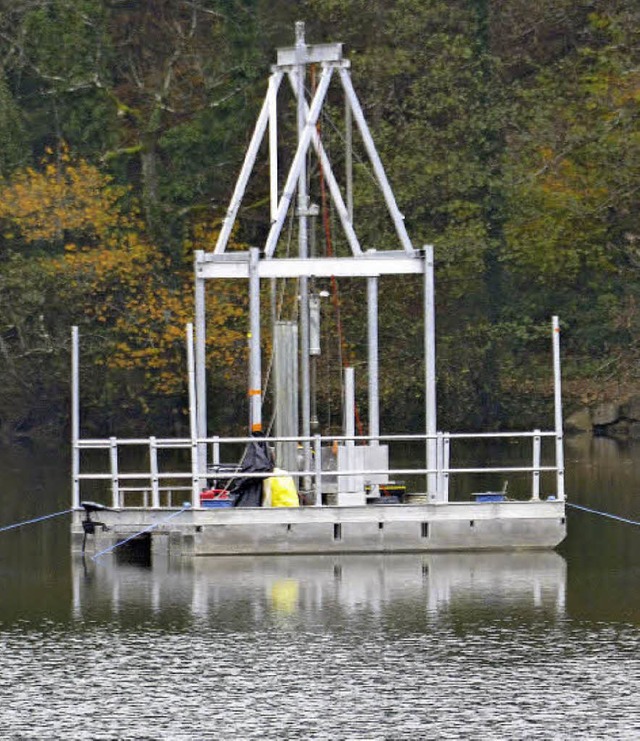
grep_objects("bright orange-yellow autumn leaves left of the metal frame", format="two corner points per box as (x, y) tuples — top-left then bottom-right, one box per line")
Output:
(0, 147), (246, 396)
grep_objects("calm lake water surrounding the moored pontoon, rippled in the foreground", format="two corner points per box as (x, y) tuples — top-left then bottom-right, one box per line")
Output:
(0, 437), (640, 741)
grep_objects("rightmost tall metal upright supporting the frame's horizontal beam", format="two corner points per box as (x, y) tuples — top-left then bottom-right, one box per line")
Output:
(424, 244), (437, 502)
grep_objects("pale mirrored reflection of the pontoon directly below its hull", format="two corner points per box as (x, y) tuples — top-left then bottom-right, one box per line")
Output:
(73, 551), (566, 628)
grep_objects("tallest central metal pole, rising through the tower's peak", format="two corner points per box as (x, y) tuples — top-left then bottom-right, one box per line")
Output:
(296, 21), (311, 489)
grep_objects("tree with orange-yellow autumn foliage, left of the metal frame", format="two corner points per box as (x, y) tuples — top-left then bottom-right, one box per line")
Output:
(0, 149), (245, 436)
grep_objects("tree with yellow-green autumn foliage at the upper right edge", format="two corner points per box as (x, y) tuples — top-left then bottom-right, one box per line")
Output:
(503, 3), (640, 368)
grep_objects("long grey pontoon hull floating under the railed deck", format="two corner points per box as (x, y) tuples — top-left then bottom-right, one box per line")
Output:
(72, 501), (567, 556)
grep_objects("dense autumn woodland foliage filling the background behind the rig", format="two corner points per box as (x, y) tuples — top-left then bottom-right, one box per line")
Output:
(0, 0), (640, 437)
